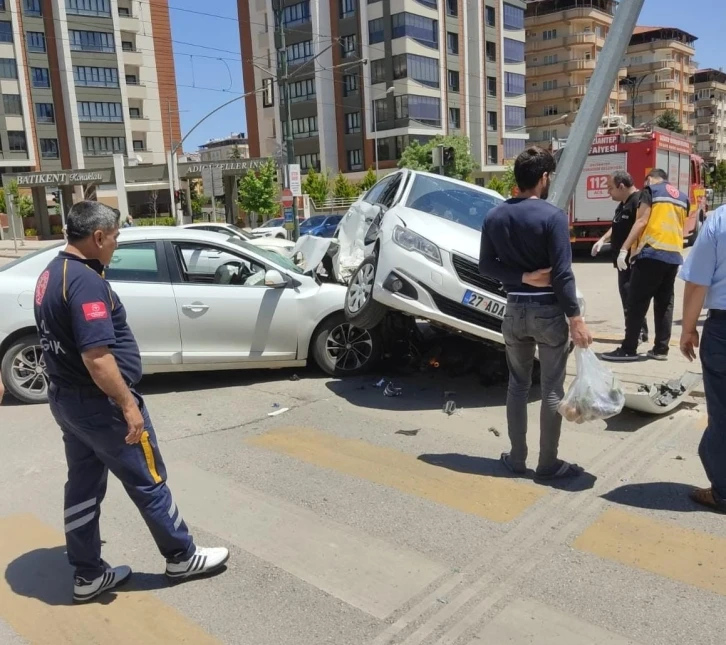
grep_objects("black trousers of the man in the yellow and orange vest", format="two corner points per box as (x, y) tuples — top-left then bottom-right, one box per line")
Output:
(623, 258), (679, 355)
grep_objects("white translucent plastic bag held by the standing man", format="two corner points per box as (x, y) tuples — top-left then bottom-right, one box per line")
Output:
(559, 347), (625, 423)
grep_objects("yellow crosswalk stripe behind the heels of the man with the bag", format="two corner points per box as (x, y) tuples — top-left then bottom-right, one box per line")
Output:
(248, 427), (547, 522)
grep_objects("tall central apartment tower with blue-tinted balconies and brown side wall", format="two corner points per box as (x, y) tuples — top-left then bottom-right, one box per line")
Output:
(238, 0), (528, 173)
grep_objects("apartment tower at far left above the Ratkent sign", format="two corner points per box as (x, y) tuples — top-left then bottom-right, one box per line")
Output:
(0, 0), (180, 173)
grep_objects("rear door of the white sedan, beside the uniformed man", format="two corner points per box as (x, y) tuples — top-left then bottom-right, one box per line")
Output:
(105, 241), (182, 371)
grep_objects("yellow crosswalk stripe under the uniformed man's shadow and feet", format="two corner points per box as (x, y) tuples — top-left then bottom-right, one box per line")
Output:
(0, 515), (219, 645)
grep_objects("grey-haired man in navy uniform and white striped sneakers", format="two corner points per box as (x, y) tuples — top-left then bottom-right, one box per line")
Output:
(35, 201), (229, 602)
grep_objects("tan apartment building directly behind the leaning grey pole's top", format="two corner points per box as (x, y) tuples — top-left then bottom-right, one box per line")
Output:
(525, 0), (626, 145)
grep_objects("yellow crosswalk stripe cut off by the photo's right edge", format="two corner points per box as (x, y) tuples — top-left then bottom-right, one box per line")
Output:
(573, 509), (726, 595)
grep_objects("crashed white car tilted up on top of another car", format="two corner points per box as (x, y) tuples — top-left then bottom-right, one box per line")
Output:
(344, 170), (584, 344)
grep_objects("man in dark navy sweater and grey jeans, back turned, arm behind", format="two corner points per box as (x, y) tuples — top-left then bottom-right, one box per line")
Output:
(479, 147), (592, 480)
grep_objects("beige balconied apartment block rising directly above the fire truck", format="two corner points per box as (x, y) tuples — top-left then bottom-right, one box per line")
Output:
(624, 27), (696, 135)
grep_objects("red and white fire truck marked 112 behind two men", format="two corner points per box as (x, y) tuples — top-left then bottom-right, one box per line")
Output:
(570, 118), (708, 247)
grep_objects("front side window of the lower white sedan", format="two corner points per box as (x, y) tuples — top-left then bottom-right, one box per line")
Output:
(174, 242), (266, 287)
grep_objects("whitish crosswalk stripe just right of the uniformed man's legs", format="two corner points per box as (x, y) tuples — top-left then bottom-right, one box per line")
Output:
(171, 462), (449, 619)
